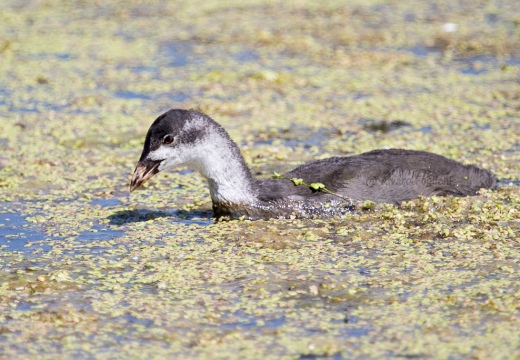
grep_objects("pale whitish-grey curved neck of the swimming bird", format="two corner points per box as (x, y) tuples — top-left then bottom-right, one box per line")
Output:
(193, 131), (256, 204)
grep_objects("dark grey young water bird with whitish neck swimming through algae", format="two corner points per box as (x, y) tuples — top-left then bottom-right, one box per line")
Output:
(130, 109), (497, 220)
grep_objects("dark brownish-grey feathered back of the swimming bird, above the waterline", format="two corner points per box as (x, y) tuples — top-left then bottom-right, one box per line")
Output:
(261, 149), (497, 203)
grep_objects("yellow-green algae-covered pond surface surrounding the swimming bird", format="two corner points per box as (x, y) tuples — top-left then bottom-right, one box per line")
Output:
(0, 0), (520, 359)
